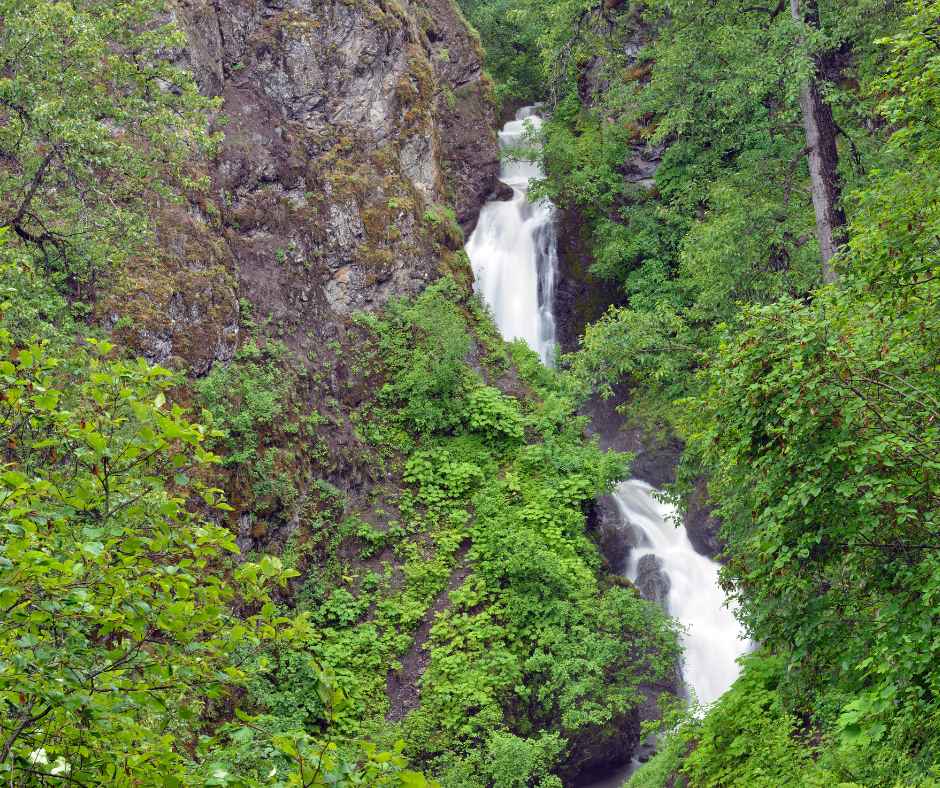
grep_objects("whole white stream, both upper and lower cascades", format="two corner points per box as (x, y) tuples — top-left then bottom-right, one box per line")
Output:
(466, 107), (748, 788)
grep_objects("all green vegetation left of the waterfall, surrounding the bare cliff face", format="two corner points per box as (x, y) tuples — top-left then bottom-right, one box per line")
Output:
(0, 0), (677, 776)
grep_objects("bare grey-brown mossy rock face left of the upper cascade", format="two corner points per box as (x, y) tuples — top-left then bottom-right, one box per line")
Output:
(106, 0), (499, 374)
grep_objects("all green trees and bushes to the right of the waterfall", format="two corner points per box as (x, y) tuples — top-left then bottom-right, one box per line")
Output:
(458, 0), (940, 786)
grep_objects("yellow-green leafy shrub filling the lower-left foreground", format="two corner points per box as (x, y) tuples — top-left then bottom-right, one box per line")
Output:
(0, 240), (434, 788)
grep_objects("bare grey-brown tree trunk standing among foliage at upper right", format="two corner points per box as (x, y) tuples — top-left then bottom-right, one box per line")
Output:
(790, 0), (845, 284)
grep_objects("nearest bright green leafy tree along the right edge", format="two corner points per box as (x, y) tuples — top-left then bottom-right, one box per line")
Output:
(652, 9), (940, 785)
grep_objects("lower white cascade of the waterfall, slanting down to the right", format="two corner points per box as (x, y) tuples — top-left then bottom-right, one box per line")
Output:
(613, 480), (748, 705)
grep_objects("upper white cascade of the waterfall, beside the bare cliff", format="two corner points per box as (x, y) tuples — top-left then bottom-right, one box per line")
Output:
(466, 107), (558, 364)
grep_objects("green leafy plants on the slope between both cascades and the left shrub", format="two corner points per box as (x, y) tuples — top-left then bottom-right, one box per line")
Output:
(282, 280), (676, 786)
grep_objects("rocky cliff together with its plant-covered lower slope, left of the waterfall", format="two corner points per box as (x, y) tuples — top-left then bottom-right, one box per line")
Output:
(98, 0), (684, 786)
